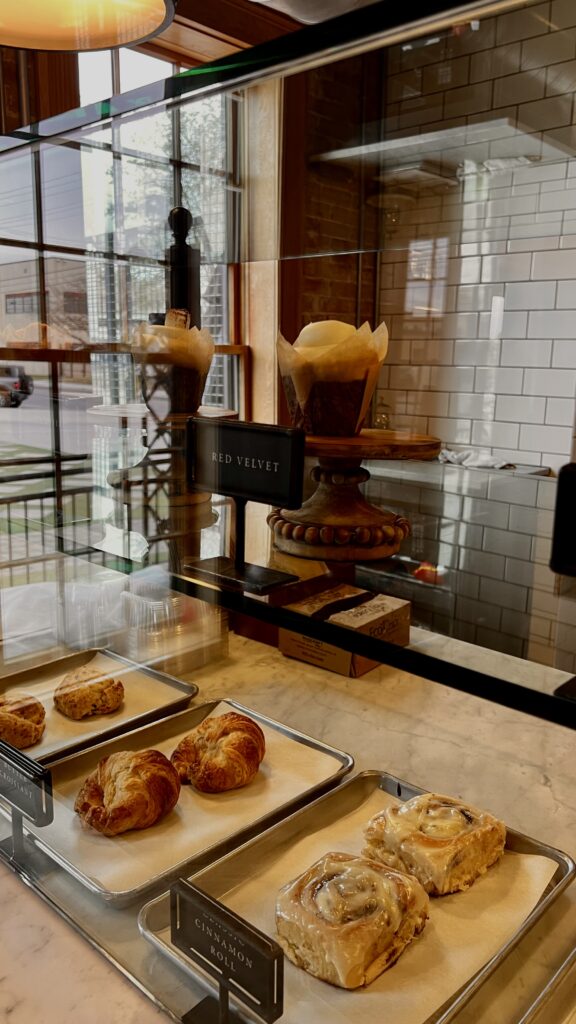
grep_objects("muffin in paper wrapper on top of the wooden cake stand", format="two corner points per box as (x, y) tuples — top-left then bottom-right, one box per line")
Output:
(277, 321), (388, 437)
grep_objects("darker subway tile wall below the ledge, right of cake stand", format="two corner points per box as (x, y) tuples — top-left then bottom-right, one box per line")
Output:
(365, 461), (576, 673)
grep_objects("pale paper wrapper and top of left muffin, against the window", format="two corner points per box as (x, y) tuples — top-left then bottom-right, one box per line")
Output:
(132, 324), (214, 411)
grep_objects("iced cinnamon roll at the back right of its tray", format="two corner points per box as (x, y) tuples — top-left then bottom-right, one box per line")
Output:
(363, 793), (506, 896)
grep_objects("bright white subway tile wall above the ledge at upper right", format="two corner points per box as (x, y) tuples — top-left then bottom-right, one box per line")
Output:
(375, 0), (576, 468)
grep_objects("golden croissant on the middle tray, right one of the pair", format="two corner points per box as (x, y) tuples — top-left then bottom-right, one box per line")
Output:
(170, 712), (265, 793)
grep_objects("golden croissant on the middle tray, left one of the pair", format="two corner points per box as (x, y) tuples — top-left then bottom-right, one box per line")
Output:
(74, 751), (180, 836)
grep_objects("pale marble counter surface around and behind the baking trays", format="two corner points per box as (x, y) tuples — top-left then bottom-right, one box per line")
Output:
(0, 636), (576, 1024)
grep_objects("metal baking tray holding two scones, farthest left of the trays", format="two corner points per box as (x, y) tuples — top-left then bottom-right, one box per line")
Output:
(0, 647), (198, 765)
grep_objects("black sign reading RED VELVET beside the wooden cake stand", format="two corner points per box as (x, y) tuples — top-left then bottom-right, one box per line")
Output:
(188, 418), (305, 508)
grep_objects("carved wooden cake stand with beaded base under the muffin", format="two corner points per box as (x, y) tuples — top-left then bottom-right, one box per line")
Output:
(268, 430), (441, 562)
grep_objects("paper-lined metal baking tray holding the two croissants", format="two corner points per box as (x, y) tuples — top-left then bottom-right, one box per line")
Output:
(17, 699), (354, 905)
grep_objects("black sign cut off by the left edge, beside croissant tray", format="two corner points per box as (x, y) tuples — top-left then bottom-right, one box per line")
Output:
(0, 740), (54, 825)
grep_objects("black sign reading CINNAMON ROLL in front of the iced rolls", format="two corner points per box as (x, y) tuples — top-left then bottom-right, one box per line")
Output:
(170, 880), (284, 1024)
